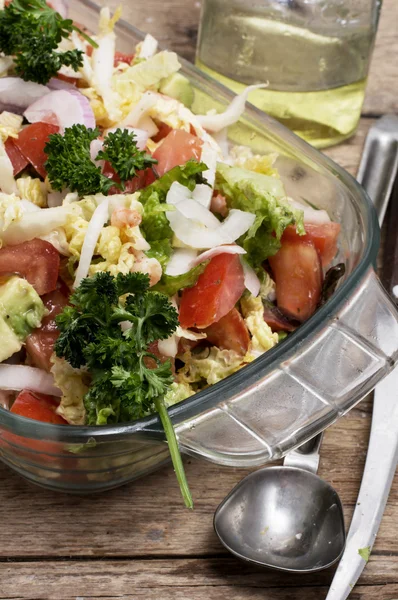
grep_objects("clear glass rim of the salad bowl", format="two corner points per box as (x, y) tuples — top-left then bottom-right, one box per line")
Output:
(0, 0), (380, 443)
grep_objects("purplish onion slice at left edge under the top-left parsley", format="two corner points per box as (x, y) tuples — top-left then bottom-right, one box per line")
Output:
(0, 77), (50, 115)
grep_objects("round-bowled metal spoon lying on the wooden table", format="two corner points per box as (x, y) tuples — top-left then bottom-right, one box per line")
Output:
(214, 434), (345, 573)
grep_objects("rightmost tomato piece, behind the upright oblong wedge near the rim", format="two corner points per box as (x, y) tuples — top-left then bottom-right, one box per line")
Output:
(282, 222), (341, 267)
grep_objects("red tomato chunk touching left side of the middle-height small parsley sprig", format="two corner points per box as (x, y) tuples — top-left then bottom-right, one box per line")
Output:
(14, 123), (59, 179)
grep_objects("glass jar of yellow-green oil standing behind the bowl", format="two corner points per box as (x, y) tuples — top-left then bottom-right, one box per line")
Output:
(197, 0), (374, 148)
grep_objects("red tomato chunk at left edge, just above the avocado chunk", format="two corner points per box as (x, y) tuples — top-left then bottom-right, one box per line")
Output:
(0, 239), (60, 296)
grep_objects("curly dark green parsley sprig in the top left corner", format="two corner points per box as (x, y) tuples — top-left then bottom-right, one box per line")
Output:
(0, 0), (98, 84)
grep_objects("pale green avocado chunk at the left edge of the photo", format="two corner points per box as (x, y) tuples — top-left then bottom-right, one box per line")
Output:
(0, 276), (46, 362)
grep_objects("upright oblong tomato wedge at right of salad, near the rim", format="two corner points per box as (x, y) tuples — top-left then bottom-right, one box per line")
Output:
(268, 236), (322, 321)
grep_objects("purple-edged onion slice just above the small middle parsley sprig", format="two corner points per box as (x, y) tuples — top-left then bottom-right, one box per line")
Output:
(24, 88), (95, 131)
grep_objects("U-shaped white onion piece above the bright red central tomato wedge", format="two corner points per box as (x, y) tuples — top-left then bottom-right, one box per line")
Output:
(166, 209), (256, 249)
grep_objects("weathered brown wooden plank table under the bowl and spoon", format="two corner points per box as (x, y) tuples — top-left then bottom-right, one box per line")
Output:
(0, 0), (398, 600)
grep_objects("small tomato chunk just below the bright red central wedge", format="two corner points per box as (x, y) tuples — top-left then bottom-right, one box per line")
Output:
(204, 307), (250, 356)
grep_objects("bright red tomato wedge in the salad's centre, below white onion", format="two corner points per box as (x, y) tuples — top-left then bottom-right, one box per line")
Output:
(179, 254), (245, 329)
